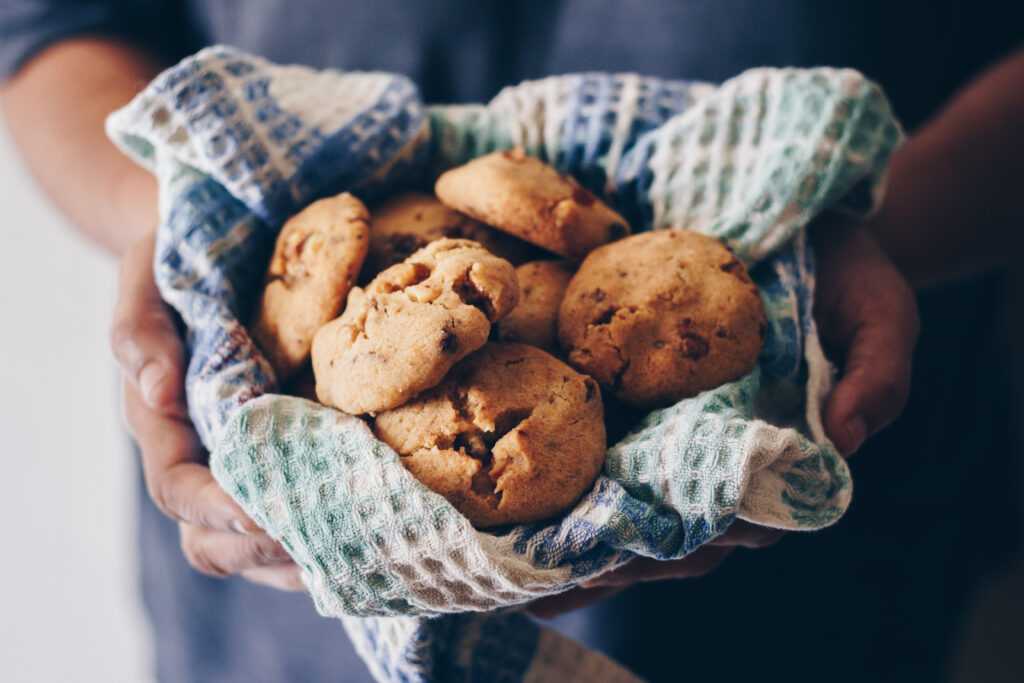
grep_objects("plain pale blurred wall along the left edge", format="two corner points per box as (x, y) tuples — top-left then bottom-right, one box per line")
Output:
(0, 126), (148, 683)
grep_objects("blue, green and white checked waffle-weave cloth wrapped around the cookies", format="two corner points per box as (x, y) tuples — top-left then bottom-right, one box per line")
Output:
(109, 47), (901, 681)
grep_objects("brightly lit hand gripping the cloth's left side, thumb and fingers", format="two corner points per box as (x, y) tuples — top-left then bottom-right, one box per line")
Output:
(111, 236), (303, 591)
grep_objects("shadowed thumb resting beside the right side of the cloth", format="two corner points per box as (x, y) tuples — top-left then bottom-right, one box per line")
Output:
(824, 283), (919, 456)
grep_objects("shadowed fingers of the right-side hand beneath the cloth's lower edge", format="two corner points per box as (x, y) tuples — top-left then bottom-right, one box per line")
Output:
(526, 520), (784, 618)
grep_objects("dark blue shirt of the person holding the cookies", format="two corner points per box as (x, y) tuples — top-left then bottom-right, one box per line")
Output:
(0, 0), (1022, 683)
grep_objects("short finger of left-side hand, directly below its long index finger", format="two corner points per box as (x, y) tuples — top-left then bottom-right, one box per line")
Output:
(178, 523), (292, 578)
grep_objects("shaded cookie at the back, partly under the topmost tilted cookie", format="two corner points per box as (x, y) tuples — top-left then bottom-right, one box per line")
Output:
(362, 193), (534, 280)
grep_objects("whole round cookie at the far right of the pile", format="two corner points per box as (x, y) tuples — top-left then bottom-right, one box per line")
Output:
(558, 229), (765, 408)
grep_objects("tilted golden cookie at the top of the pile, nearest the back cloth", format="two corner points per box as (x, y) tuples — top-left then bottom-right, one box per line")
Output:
(434, 148), (630, 258)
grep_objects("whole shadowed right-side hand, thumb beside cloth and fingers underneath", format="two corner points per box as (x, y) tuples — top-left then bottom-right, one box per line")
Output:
(527, 217), (920, 618)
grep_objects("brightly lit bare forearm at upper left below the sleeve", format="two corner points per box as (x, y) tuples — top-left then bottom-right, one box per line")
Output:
(0, 39), (160, 254)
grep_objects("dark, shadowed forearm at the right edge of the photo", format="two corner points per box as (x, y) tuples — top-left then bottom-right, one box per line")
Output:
(868, 52), (1024, 287)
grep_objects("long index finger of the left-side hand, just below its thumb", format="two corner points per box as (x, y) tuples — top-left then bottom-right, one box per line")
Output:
(124, 381), (260, 533)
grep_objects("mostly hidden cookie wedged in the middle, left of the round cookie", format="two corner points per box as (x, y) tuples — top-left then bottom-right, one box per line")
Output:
(498, 261), (573, 350)
